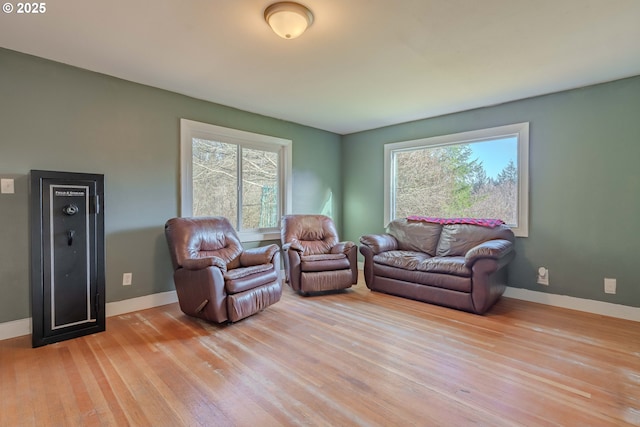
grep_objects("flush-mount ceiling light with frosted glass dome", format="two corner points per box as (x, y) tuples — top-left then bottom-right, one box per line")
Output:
(264, 1), (313, 39)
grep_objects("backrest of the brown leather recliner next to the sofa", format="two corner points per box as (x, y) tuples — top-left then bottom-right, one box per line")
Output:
(280, 215), (340, 255)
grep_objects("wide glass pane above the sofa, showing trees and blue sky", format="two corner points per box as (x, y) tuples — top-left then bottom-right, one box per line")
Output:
(392, 137), (518, 225)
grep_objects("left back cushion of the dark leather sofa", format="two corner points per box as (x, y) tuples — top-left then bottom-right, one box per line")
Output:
(387, 218), (442, 256)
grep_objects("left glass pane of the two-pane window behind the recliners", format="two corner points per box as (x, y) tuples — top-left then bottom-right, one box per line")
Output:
(192, 138), (238, 224)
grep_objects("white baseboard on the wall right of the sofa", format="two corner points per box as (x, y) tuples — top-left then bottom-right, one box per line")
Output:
(504, 287), (640, 322)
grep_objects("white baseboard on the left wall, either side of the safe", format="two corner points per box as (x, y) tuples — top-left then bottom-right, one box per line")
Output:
(0, 291), (178, 340)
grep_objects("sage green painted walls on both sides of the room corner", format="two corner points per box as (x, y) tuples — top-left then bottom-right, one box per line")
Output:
(0, 49), (640, 323)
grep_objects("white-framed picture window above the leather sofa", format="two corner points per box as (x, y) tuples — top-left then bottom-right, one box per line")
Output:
(384, 123), (529, 237)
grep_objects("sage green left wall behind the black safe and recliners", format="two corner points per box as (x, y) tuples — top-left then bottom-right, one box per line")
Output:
(0, 49), (342, 323)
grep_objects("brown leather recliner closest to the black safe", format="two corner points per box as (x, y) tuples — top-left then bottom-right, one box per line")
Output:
(165, 217), (282, 323)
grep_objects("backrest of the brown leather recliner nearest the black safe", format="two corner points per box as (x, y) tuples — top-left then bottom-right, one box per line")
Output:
(165, 217), (243, 270)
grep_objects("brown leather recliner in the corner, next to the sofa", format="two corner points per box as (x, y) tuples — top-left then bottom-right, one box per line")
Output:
(281, 215), (358, 294)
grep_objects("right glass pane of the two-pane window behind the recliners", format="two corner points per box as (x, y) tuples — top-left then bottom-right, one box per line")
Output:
(241, 148), (280, 230)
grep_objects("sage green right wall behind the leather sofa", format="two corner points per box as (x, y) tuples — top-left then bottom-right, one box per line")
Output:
(342, 77), (640, 307)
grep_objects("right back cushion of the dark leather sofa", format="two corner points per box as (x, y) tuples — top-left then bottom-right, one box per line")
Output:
(436, 224), (515, 256)
